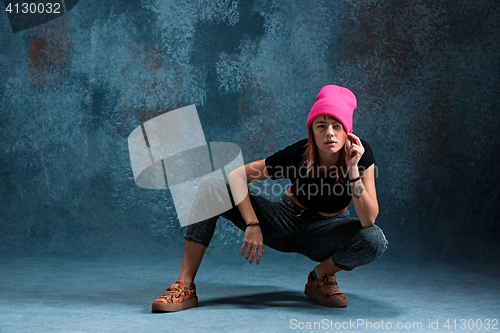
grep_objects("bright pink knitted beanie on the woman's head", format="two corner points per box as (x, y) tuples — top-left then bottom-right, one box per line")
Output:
(307, 84), (357, 134)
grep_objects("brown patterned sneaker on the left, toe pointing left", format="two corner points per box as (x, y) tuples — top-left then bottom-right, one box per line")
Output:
(152, 281), (198, 312)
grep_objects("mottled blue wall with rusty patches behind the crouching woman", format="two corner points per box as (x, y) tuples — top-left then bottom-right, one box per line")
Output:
(0, 0), (500, 260)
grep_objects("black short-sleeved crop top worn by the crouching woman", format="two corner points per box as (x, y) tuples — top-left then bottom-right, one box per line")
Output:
(265, 139), (375, 213)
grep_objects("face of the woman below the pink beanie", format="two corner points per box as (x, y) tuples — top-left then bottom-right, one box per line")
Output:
(312, 116), (346, 153)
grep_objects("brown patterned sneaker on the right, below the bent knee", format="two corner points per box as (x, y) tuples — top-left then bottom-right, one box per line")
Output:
(304, 271), (347, 308)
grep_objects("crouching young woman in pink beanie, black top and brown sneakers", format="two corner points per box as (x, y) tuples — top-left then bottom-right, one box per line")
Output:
(152, 85), (388, 312)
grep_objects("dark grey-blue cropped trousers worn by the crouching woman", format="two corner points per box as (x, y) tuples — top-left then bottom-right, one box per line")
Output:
(184, 178), (389, 271)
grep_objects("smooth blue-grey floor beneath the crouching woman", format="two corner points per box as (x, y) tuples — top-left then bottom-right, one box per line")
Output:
(0, 249), (500, 332)
